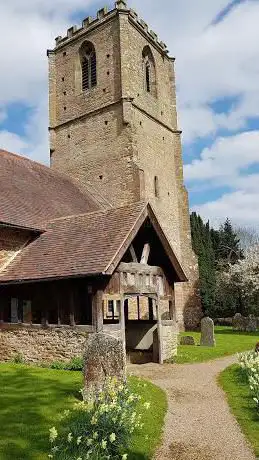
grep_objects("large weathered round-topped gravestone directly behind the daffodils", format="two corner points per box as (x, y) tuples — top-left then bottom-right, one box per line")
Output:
(84, 333), (126, 391)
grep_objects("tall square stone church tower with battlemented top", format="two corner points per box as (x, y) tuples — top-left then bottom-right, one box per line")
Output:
(48, 0), (202, 326)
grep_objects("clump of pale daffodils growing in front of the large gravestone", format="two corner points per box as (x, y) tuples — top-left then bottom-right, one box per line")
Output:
(49, 379), (149, 460)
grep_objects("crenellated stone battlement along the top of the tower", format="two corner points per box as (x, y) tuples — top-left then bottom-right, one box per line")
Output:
(55, 0), (168, 54)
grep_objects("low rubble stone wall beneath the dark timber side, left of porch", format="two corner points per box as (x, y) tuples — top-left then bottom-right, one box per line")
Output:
(0, 324), (91, 363)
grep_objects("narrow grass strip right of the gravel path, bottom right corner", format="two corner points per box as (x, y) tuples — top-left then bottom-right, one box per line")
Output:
(218, 365), (259, 457)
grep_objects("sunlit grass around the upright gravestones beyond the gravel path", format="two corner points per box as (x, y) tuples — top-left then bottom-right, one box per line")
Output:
(174, 326), (259, 363)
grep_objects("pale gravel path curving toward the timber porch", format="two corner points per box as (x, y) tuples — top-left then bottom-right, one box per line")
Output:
(129, 357), (255, 460)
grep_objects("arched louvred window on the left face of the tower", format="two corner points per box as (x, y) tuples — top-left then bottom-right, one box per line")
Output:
(80, 42), (97, 91)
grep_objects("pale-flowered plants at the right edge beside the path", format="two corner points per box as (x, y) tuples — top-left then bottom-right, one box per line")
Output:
(239, 351), (259, 413)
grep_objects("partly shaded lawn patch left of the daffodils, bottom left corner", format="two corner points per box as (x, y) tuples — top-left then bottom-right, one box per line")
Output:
(0, 366), (79, 460)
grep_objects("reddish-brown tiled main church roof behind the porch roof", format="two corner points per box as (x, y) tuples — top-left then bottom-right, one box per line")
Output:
(0, 150), (99, 228)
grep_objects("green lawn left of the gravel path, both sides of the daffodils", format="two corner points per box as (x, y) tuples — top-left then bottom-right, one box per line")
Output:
(0, 364), (167, 460)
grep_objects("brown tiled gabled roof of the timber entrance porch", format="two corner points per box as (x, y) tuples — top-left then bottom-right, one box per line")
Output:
(0, 202), (186, 283)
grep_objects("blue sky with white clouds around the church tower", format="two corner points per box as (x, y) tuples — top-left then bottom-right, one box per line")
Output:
(0, 0), (259, 228)
